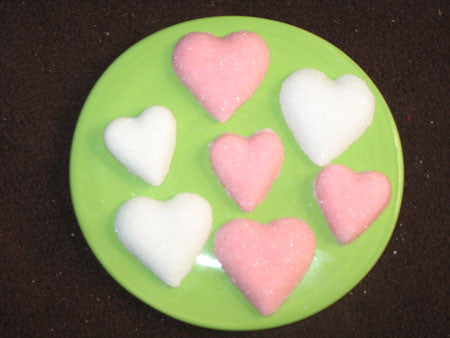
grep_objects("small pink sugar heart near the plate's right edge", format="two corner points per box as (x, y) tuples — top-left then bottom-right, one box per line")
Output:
(314, 164), (391, 244)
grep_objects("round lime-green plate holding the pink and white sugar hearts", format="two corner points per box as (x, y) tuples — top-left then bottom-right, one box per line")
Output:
(70, 17), (403, 330)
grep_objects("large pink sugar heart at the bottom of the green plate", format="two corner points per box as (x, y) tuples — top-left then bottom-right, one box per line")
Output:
(214, 218), (316, 316)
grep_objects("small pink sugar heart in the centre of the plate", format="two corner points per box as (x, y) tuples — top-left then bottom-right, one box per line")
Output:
(209, 129), (284, 212)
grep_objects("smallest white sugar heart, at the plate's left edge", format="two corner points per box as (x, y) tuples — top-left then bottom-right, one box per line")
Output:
(103, 106), (177, 186)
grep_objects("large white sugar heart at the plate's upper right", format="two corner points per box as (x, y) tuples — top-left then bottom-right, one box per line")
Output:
(280, 68), (375, 166)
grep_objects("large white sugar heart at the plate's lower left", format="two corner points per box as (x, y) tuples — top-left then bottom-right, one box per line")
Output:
(114, 193), (212, 287)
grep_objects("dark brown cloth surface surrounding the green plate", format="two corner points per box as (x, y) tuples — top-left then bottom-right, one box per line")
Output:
(0, 0), (450, 337)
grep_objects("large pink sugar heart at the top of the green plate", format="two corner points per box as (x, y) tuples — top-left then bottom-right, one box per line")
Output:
(172, 31), (270, 122)
